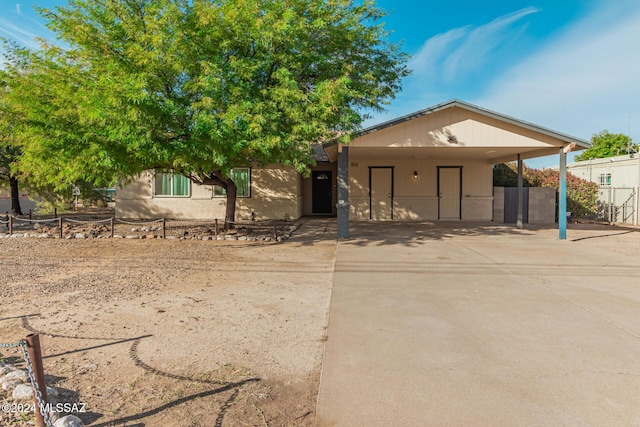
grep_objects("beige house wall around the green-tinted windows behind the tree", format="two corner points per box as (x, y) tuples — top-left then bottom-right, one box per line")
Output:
(116, 166), (303, 221)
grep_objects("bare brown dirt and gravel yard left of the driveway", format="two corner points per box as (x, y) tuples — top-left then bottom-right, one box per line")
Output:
(0, 224), (336, 427)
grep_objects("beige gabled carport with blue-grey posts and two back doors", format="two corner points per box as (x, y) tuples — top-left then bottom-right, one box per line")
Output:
(325, 100), (589, 239)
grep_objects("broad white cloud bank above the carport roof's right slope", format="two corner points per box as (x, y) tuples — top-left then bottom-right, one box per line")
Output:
(474, 0), (640, 150)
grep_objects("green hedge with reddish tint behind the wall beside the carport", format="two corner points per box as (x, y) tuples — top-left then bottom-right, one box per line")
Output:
(493, 162), (598, 217)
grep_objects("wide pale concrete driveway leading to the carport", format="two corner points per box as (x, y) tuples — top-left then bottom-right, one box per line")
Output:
(317, 223), (640, 426)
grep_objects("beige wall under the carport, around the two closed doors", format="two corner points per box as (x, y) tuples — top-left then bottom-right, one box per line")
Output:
(349, 156), (493, 221)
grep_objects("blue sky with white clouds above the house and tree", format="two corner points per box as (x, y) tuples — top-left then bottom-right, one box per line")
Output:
(0, 0), (640, 168)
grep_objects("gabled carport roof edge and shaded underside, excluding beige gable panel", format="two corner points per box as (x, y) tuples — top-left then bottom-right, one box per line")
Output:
(324, 99), (590, 164)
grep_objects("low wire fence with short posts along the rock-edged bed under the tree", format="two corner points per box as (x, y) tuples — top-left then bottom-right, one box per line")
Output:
(0, 215), (297, 242)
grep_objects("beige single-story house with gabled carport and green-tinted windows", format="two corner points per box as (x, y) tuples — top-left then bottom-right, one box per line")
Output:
(116, 100), (589, 236)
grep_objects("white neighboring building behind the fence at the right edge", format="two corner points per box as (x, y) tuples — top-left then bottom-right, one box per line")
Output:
(567, 154), (640, 225)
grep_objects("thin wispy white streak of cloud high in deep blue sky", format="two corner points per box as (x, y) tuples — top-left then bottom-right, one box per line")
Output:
(409, 7), (540, 81)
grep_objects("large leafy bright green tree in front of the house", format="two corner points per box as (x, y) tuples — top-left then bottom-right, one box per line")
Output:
(5, 0), (408, 225)
